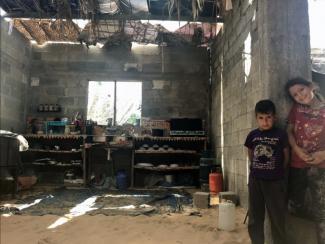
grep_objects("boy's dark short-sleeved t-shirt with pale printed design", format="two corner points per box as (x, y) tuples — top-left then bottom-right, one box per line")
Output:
(245, 128), (288, 180)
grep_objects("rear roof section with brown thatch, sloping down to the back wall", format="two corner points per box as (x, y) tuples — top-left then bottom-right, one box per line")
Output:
(14, 19), (221, 45)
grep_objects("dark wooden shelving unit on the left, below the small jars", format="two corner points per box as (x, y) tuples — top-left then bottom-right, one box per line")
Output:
(21, 134), (86, 184)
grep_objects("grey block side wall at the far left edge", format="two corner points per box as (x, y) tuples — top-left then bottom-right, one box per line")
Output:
(0, 18), (31, 133)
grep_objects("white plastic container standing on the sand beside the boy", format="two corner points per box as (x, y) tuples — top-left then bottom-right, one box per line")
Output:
(218, 202), (236, 231)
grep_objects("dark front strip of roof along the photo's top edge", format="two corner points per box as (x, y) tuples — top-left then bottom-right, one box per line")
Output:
(0, 0), (222, 22)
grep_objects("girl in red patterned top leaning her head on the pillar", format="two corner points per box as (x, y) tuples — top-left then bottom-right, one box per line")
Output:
(285, 78), (325, 243)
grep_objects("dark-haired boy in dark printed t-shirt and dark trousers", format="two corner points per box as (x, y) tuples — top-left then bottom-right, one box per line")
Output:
(245, 100), (289, 244)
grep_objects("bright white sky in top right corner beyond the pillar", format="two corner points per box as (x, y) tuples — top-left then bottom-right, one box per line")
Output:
(308, 0), (325, 48)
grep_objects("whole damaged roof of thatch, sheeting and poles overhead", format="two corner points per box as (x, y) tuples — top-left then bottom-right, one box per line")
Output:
(0, 0), (223, 47)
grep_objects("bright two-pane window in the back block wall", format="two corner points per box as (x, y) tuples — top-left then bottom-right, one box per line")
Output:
(87, 81), (142, 125)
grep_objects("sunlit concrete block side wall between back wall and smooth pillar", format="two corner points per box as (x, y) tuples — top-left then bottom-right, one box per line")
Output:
(211, 1), (260, 206)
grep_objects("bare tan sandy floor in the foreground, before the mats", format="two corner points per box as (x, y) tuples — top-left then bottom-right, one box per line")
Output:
(1, 208), (250, 244)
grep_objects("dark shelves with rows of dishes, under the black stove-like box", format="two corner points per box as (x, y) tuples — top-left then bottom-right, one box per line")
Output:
(131, 137), (206, 187)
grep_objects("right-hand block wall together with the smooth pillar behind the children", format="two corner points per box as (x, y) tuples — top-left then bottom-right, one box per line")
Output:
(211, 0), (316, 244)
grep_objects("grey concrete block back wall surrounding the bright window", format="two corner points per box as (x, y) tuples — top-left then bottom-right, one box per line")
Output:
(29, 44), (208, 122)
